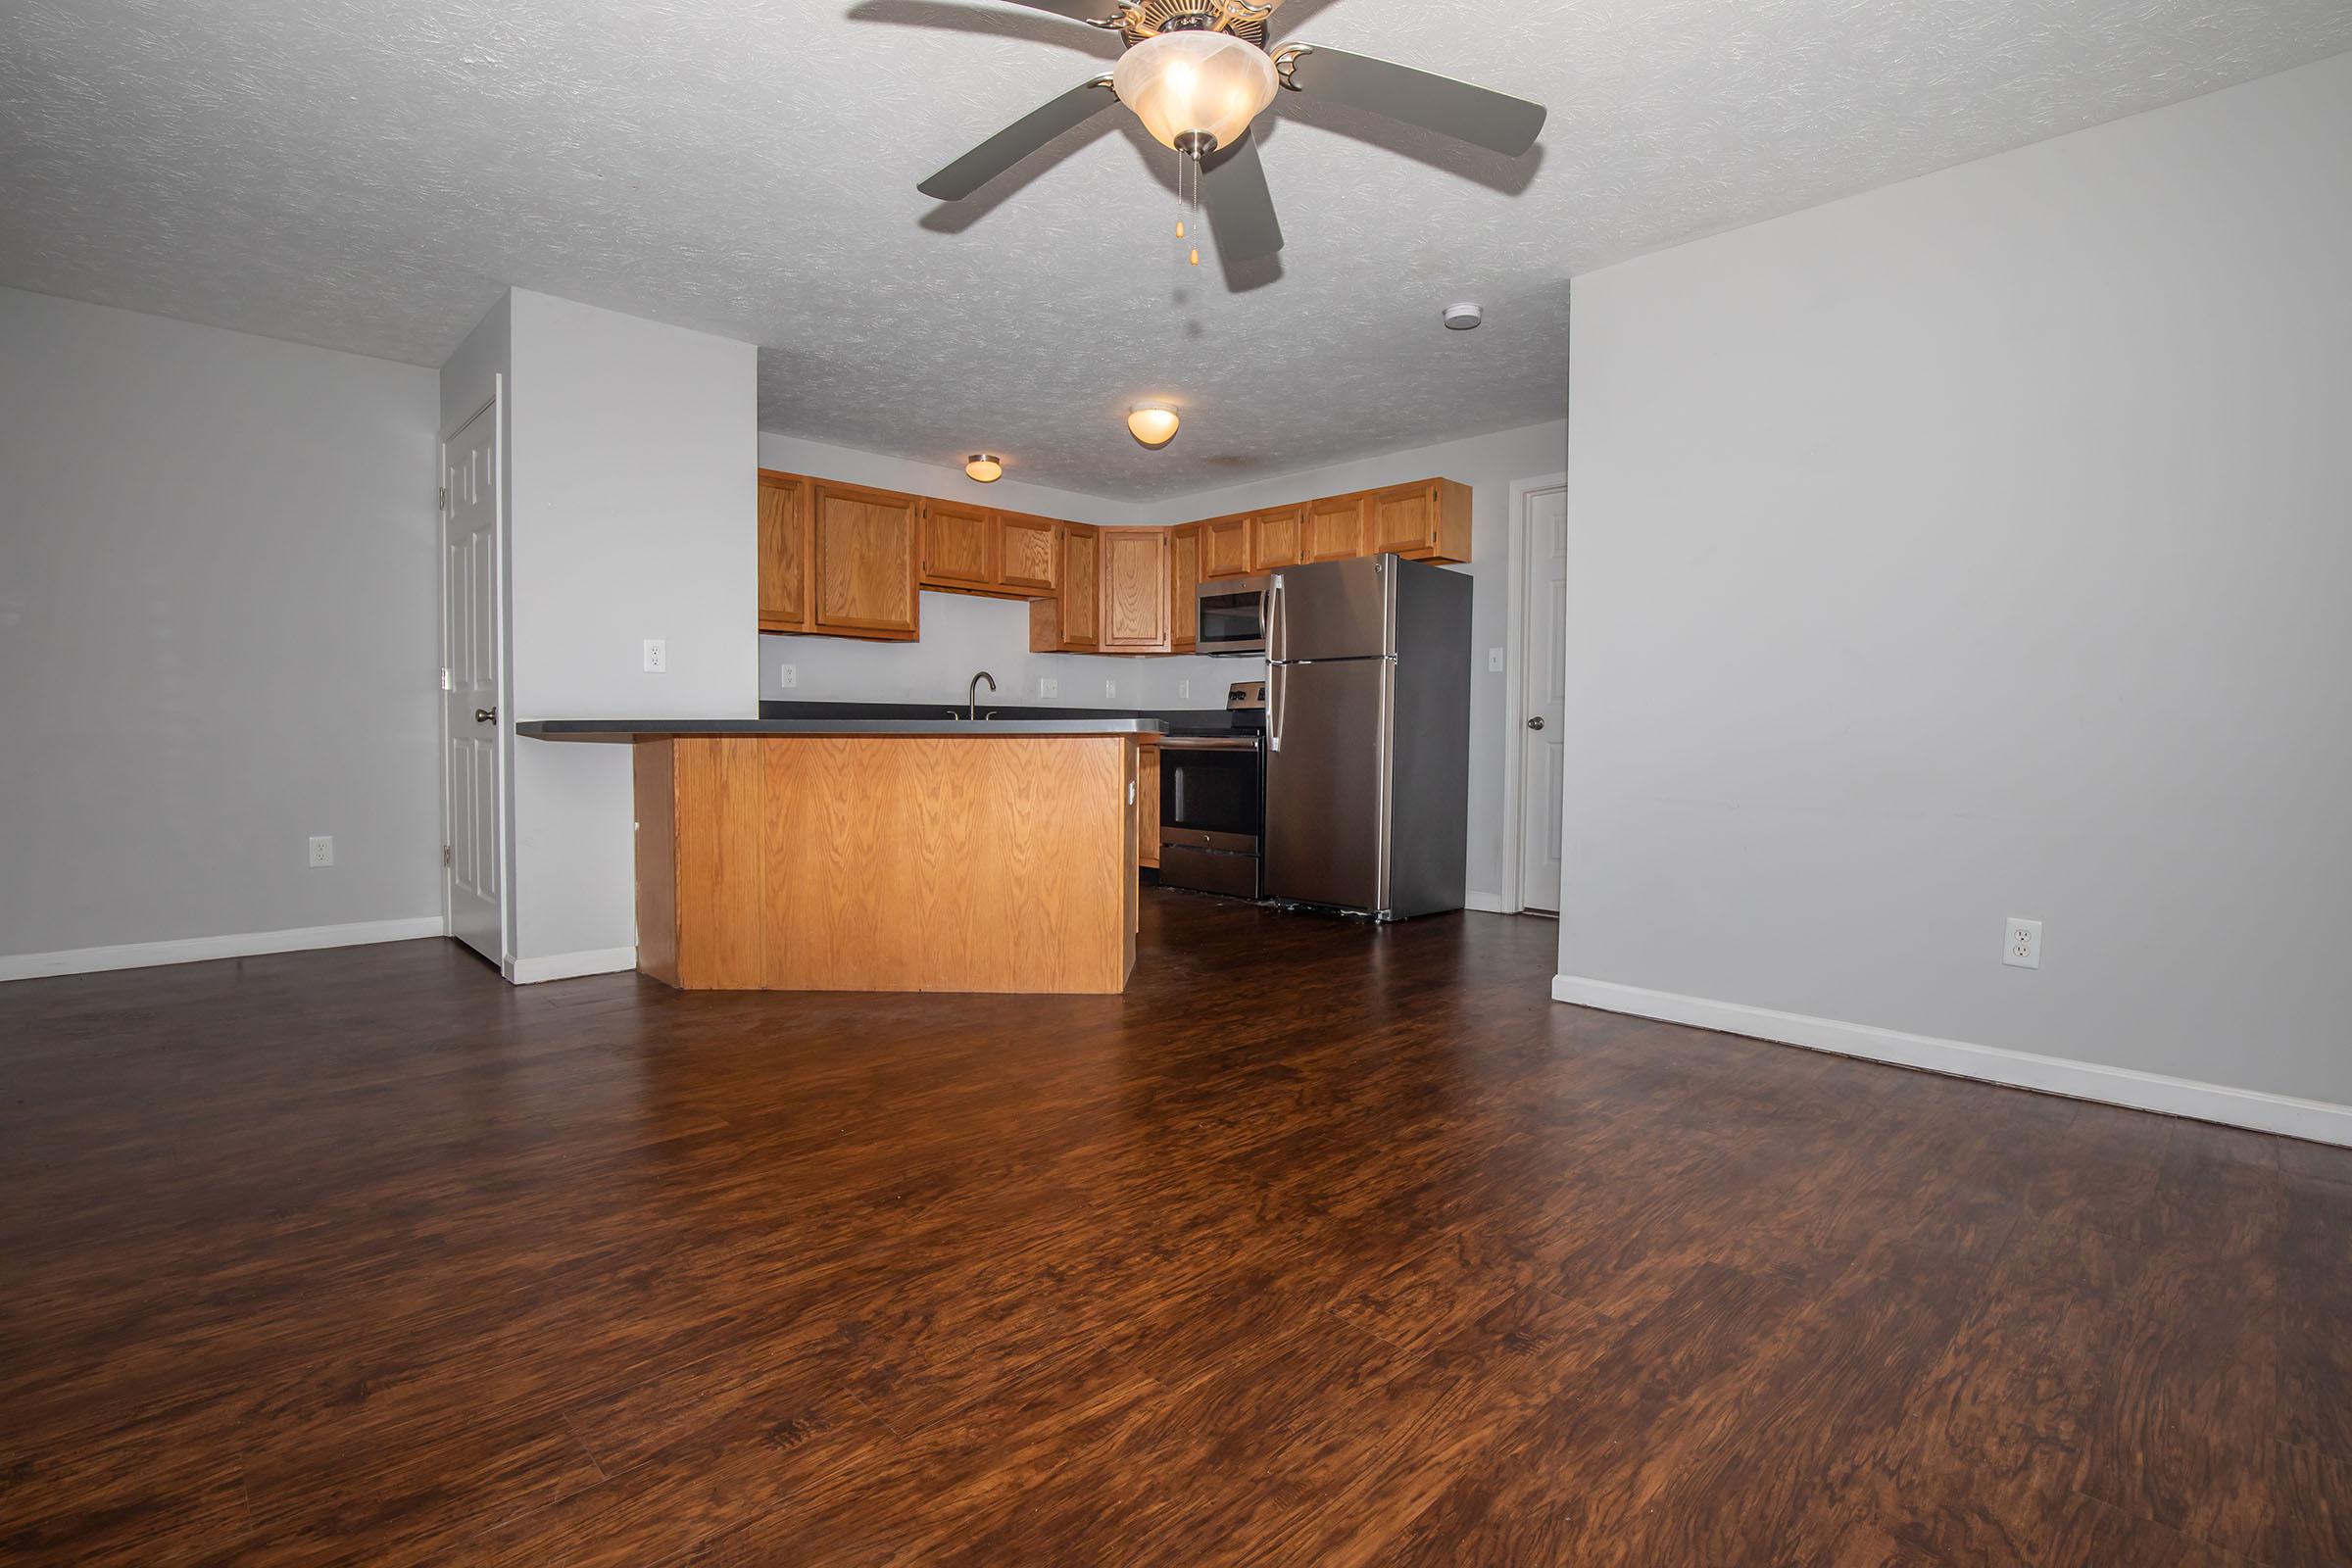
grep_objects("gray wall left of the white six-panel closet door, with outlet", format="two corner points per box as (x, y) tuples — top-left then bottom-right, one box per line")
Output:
(0, 289), (440, 955)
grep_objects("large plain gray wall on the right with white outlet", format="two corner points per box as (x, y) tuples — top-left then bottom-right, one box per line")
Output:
(1559, 57), (2352, 1102)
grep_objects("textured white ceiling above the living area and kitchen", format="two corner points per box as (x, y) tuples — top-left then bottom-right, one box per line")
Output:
(0, 0), (2352, 499)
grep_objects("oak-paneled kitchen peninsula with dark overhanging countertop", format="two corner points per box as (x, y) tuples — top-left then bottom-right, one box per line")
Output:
(515, 717), (1162, 992)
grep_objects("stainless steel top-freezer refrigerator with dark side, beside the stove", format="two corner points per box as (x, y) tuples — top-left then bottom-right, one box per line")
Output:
(1265, 555), (1470, 919)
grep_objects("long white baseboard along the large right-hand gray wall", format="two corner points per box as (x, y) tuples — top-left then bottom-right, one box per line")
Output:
(1552, 976), (2352, 1148)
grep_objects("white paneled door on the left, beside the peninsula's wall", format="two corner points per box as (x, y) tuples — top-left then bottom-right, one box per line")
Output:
(442, 405), (506, 964)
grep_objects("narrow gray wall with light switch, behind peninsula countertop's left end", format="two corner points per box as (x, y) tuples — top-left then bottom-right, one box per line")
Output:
(508, 289), (760, 966)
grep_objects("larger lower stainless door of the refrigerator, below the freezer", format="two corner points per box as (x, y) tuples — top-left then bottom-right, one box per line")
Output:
(1265, 659), (1397, 912)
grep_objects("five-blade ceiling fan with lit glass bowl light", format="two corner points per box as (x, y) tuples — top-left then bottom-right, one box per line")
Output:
(915, 0), (1545, 261)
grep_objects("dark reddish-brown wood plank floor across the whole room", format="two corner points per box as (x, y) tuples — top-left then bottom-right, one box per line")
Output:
(0, 894), (2352, 1568)
